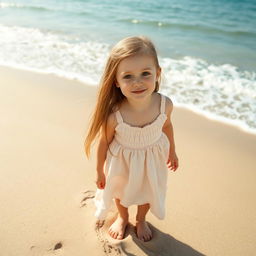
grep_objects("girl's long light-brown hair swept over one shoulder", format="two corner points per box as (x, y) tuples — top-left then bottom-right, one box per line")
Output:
(84, 36), (160, 157)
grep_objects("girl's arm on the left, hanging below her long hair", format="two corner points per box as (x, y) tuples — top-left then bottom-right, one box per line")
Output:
(96, 113), (116, 189)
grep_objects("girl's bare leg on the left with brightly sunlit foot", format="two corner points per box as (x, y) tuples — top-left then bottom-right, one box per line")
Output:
(108, 199), (129, 240)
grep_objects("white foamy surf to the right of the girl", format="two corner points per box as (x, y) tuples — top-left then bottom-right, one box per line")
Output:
(161, 57), (256, 133)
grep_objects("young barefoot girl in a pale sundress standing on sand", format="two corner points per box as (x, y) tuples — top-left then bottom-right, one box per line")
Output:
(85, 37), (178, 241)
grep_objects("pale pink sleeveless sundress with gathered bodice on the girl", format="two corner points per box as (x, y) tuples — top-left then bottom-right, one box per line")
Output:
(94, 94), (169, 220)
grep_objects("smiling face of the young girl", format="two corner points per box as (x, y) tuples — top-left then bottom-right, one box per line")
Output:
(116, 54), (161, 99)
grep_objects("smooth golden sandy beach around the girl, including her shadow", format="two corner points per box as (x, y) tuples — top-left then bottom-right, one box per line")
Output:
(0, 67), (256, 256)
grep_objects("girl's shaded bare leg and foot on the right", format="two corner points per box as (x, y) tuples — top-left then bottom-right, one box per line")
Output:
(136, 204), (152, 242)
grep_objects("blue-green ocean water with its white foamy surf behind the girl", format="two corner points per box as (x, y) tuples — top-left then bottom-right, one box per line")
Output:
(0, 0), (256, 133)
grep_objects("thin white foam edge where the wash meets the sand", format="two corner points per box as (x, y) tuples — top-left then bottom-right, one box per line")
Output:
(0, 64), (256, 136)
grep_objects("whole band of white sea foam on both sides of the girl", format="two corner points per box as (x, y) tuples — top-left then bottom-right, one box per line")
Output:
(0, 25), (256, 134)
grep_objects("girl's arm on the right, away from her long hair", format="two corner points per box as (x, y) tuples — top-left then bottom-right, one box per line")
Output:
(163, 97), (179, 171)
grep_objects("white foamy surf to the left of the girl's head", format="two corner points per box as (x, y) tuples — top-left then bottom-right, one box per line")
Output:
(0, 25), (109, 84)
